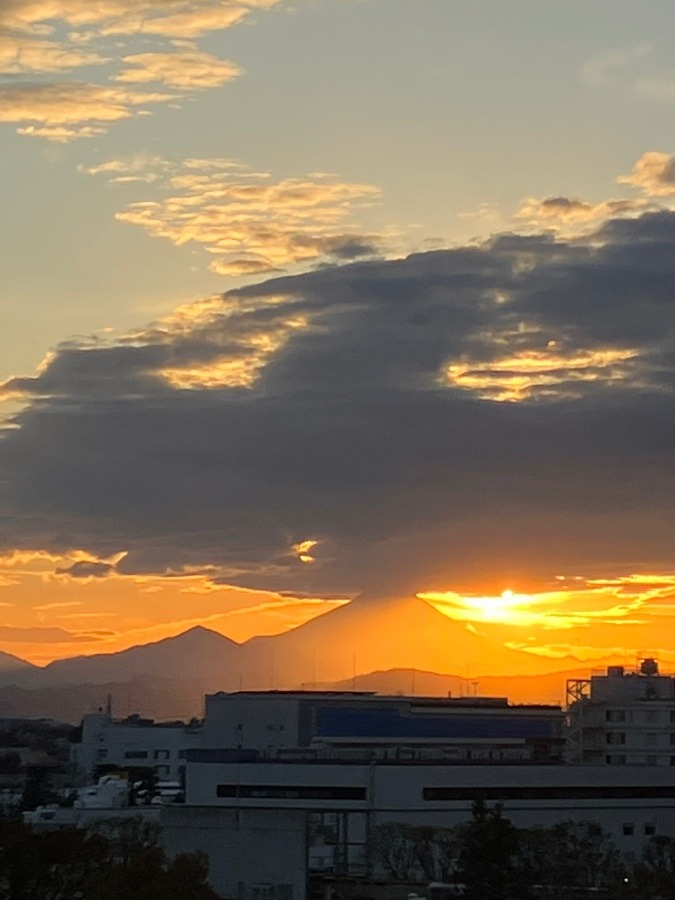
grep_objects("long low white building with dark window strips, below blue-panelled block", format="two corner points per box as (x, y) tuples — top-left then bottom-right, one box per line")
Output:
(161, 751), (675, 900)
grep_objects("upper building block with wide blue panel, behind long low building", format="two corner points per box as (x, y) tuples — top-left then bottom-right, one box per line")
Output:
(202, 691), (564, 764)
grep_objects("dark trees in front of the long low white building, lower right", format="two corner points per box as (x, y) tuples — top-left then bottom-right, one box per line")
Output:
(368, 801), (675, 900)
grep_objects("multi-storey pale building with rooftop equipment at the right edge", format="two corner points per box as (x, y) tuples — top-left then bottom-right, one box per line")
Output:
(567, 659), (675, 766)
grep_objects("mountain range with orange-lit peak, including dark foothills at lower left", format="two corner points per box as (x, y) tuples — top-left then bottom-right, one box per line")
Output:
(0, 597), (579, 720)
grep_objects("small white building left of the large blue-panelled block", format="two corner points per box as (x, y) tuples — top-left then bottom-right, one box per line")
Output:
(72, 712), (202, 781)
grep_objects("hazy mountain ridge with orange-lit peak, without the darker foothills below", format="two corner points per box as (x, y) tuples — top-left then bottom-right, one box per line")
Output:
(0, 597), (580, 691)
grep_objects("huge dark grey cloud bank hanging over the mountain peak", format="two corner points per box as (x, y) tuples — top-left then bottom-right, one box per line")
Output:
(0, 212), (675, 594)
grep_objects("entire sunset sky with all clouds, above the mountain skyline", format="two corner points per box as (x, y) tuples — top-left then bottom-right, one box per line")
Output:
(0, 0), (675, 668)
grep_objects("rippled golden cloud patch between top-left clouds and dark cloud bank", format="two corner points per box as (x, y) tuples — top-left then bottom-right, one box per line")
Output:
(90, 159), (380, 275)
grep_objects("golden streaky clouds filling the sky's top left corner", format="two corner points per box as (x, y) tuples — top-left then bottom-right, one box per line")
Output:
(0, 0), (279, 142)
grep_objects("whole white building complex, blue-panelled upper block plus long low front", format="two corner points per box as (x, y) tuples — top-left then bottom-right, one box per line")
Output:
(157, 692), (660, 900)
